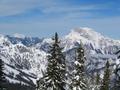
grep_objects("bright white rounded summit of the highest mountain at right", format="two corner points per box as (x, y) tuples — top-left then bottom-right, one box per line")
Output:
(65, 27), (120, 48)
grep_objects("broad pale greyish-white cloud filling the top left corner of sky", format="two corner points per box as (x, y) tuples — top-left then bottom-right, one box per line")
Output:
(0, 0), (56, 16)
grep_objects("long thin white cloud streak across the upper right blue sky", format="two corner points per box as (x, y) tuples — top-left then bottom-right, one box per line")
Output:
(43, 2), (113, 13)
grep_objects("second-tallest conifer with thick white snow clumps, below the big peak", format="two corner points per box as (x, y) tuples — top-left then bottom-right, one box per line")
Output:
(72, 43), (87, 90)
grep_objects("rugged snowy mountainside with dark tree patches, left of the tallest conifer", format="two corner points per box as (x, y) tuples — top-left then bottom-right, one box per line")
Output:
(0, 35), (46, 84)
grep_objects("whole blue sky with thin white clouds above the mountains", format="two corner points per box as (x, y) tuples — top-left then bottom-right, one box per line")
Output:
(0, 0), (120, 39)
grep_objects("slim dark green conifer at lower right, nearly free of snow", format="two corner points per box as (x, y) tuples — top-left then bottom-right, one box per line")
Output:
(100, 61), (110, 90)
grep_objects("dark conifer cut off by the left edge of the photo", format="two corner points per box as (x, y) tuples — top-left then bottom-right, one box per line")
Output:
(0, 59), (5, 90)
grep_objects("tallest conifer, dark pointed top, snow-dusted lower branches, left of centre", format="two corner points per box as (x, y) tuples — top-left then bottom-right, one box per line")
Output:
(38, 33), (65, 90)
